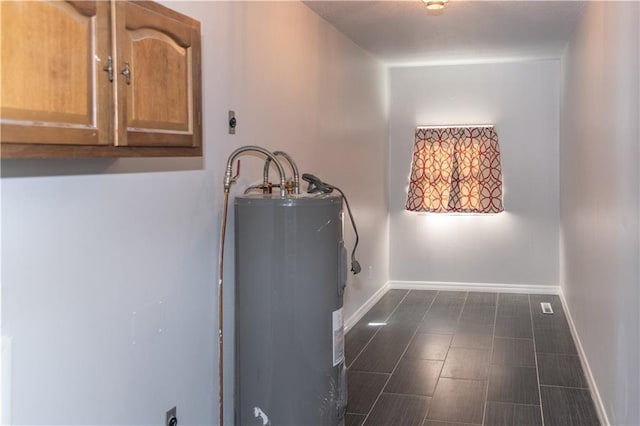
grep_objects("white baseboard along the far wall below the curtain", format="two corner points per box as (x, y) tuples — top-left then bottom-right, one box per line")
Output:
(388, 281), (560, 294)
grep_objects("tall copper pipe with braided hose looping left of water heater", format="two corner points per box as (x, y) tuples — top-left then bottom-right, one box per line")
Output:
(218, 145), (287, 426)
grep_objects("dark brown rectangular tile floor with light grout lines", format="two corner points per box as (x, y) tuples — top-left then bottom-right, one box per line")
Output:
(345, 290), (599, 426)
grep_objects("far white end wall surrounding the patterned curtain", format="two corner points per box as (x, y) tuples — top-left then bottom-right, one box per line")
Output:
(389, 60), (559, 285)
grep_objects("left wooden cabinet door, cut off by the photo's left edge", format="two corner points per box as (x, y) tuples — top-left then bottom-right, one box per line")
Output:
(0, 1), (113, 148)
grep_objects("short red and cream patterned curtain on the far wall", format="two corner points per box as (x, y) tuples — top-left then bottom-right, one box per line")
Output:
(405, 127), (504, 213)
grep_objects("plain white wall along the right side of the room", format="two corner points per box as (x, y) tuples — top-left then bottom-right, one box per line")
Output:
(560, 2), (640, 425)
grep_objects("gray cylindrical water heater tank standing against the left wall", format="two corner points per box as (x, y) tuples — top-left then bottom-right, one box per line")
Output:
(235, 194), (347, 426)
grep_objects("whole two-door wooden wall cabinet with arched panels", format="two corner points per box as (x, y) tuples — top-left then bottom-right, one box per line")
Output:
(0, 0), (202, 158)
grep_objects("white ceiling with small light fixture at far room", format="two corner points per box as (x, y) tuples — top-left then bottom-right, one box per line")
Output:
(304, 0), (585, 65)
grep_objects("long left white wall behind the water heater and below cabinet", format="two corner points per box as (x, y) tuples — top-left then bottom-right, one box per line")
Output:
(2, 2), (388, 425)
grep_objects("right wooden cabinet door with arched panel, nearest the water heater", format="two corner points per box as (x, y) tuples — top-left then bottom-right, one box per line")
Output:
(114, 2), (201, 147)
